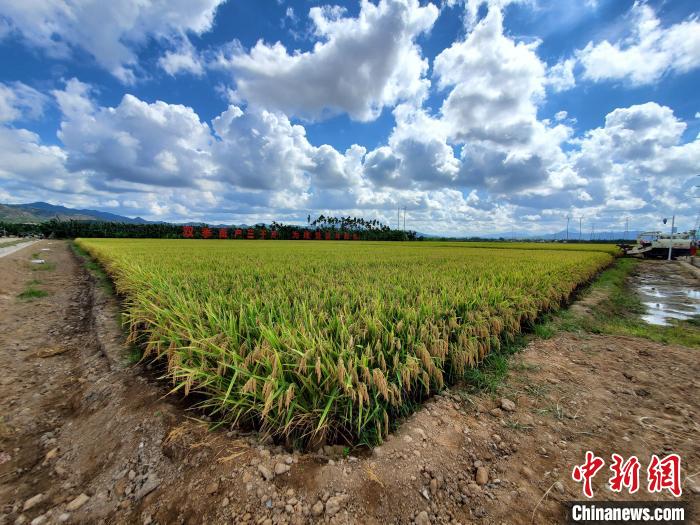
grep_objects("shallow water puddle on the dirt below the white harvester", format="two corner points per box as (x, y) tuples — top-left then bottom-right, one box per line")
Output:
(633, 264), (700, 326)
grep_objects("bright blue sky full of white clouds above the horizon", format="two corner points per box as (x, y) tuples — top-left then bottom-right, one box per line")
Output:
(0, 0), (700, 234)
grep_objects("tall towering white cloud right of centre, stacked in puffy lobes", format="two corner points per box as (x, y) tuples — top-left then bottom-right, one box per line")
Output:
(434, 6), (571, 193)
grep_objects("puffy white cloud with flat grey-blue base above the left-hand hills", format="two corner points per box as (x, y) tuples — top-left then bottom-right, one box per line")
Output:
(54, 79), (212, 187)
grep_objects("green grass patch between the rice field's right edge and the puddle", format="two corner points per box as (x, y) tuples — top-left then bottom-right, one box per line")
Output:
(534, 258), (700, 348)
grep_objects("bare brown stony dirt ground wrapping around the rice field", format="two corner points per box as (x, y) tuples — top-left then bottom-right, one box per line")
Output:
(0, 241), (700, 525)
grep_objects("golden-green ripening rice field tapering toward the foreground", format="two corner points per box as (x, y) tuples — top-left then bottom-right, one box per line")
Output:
(77, 239), (615, 446)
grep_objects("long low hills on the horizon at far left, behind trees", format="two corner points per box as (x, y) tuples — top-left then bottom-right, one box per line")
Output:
(0, 202), (150, 224)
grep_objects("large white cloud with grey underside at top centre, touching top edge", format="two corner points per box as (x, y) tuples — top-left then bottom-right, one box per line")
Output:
(217, 0), (438, 121)
